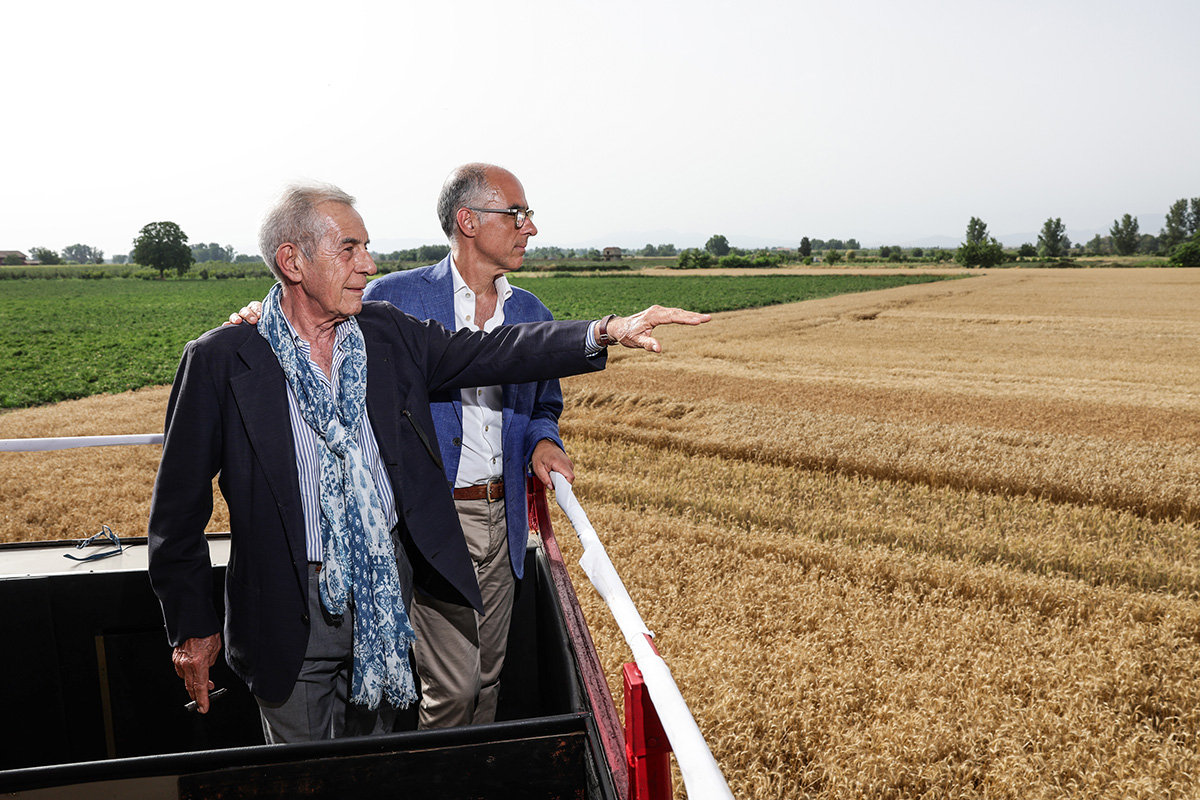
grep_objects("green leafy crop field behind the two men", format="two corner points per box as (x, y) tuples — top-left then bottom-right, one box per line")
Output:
(0, 275), (944, 408)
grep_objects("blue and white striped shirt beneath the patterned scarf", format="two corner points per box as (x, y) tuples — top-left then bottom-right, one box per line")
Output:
(277, 317), (398, 561)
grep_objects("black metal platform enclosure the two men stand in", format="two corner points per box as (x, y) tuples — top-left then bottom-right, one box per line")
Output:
(0, 540), (617, 800)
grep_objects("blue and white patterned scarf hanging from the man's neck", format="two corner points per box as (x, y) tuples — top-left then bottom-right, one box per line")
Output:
(258, 284), (416, 709)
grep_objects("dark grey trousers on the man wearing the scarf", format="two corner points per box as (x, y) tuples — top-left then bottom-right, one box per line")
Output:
(254, 534), (413, 745)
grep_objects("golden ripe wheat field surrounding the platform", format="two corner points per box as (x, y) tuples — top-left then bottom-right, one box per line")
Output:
(0, 270), (1200, 799)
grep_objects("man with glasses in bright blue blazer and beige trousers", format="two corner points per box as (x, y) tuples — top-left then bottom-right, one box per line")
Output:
(364, 163), (561, 728)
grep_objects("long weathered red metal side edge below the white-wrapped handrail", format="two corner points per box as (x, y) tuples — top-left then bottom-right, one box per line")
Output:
(527, 477), (633, 800)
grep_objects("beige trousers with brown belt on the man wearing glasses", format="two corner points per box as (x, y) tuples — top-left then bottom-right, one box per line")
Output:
(410, 500), (516, 729)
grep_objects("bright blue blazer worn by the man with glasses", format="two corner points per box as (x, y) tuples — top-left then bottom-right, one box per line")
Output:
(362, 255), (565, 579)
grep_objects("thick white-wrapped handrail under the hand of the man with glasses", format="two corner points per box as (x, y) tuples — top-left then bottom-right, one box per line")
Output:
(550, 473), (733, 800)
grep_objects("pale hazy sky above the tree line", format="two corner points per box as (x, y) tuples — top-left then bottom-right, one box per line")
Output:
(0, 0), (1200, 257)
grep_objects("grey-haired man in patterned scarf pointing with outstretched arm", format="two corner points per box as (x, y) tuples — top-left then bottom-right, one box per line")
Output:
(149, 187), (707, 741)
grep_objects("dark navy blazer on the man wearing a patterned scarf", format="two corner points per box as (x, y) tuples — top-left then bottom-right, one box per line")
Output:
(148, 302), (605, 702)
